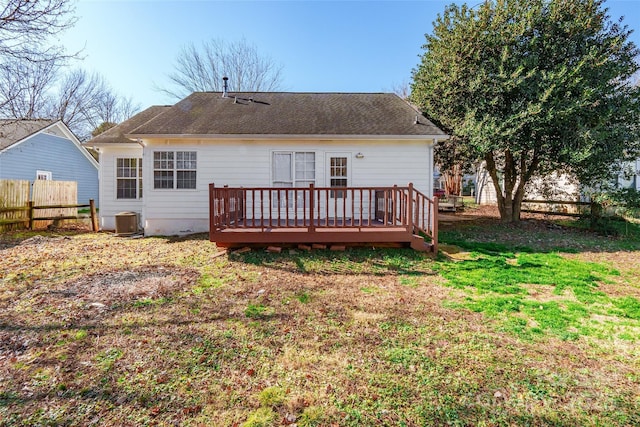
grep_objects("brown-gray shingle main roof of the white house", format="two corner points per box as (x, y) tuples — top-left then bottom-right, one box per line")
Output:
(131, 92), (445, 137)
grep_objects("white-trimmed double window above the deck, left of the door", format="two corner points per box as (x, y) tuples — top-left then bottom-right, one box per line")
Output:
(272, 151), (316, 207)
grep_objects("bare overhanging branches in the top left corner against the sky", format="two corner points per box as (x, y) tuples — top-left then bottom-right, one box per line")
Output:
(0, 0), (76, 63)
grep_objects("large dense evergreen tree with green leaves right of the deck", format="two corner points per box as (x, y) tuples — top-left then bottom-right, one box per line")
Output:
(411, 0), (640, 221)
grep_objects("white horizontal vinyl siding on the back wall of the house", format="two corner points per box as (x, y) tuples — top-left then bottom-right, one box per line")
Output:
(100, 138), (433, 235)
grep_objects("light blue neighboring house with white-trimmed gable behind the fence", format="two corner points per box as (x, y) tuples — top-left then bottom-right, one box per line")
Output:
(0, 119), (98, 203)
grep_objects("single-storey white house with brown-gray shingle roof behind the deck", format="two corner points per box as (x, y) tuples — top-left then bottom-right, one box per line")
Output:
(87, 92), (447, 235)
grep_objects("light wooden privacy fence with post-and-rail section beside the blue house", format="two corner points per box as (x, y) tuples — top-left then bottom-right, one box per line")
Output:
(0, 180), (98, 231)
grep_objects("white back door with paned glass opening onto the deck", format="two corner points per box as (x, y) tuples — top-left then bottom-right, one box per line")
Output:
(326, 153), (352, 225)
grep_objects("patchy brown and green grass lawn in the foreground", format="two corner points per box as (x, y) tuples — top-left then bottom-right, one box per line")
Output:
(0, 216), (640, 426)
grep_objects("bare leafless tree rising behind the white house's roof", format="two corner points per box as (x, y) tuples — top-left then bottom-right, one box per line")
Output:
(159, 39), (282, 99)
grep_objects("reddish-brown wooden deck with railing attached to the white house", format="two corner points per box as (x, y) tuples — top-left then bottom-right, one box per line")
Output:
(209, 184), (438, 252)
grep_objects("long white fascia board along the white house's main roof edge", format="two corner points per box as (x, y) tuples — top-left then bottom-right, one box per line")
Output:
(124, 134), (449, 141)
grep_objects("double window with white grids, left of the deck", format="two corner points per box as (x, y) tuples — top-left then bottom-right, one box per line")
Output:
(153, 151), (198, 190)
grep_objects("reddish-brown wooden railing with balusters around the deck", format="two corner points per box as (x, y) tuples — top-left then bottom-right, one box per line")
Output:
(209, 184), (438, 249)
